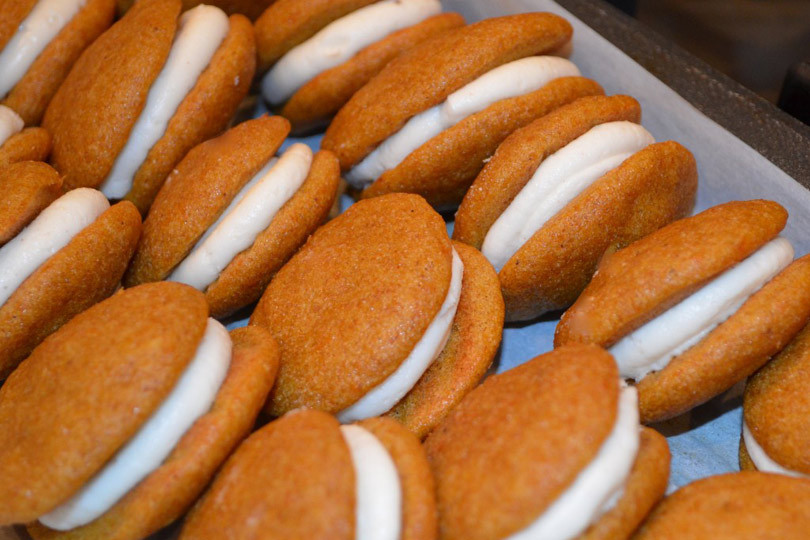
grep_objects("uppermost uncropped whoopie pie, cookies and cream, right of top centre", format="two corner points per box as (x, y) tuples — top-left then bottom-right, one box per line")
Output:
(321, 13), (602, 207)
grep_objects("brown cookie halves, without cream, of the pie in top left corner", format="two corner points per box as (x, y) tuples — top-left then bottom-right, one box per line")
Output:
(0, 0), (115, 126)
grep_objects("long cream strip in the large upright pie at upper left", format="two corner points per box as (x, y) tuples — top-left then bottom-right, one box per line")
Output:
(101, 5), (229, 199)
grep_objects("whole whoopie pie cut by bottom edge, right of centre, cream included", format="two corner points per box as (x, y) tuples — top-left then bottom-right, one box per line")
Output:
(425, 345), (669, 540)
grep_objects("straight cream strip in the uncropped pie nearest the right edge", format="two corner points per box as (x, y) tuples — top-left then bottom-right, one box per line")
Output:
(610, 238), (793, 381)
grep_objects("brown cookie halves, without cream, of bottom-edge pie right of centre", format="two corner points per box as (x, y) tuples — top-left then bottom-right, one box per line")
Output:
(425, 346), (669, 539)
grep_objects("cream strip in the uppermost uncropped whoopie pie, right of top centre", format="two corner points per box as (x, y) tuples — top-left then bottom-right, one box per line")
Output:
(345, 56), (579, 189)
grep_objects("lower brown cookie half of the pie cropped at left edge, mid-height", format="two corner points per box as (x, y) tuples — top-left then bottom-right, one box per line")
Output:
(0, 194), (141, 380)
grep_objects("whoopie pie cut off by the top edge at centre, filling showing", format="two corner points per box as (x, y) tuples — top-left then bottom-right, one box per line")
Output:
(255, 0), (464, 132)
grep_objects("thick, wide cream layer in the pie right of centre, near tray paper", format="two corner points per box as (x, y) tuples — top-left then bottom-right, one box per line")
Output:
(481, 122), (655, 272)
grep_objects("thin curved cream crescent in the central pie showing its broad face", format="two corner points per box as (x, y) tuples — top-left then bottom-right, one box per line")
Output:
(337, 249), (464, 424)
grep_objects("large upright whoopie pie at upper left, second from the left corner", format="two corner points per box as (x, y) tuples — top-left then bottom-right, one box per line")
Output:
(43, 0), (255, 213)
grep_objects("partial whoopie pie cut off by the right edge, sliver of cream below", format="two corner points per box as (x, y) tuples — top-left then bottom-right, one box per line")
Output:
(740, 320), (810, 478)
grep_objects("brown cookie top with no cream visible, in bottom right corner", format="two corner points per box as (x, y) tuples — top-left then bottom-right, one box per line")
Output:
(633, 471), (810, 540)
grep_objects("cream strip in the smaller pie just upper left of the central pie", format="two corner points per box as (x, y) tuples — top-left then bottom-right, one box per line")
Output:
(167, 143), (312, 291)
